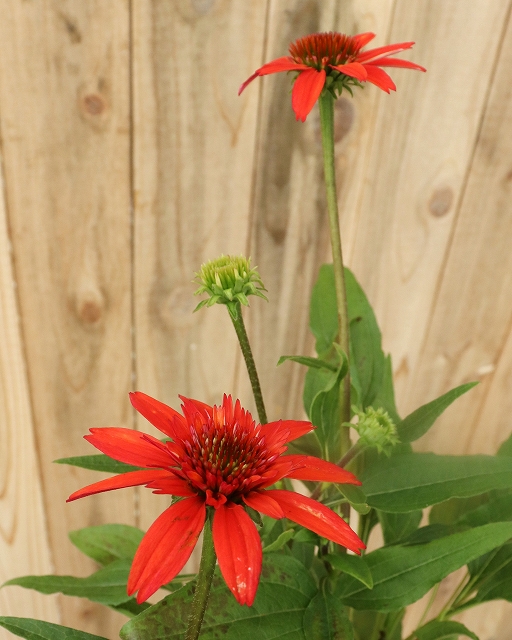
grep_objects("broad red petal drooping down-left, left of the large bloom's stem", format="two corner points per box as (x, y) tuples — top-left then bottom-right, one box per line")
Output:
(127, 497), (206, 603)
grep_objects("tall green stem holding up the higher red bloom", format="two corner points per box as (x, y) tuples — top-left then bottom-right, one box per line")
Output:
(318, 90), (350, 455)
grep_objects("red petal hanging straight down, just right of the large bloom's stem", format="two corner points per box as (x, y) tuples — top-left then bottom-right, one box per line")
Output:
(212, 503), (262, 607)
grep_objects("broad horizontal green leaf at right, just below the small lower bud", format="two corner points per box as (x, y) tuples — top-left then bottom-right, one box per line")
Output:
(361, 453), (512, 513)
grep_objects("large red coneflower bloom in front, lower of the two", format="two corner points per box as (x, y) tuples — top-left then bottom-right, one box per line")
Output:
(68, 392), (365, 605)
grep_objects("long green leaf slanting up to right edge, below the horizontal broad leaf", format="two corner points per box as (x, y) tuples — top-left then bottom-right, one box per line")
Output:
(335, 522), (512, 611)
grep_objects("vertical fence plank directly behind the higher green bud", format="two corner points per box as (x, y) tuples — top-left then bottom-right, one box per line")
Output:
(133, 0), (266, 556)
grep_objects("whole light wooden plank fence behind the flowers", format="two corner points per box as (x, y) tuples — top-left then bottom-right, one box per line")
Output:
(0, 0), (512, 640)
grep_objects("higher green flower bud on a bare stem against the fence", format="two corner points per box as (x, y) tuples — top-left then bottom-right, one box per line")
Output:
(194, 255), (267, 311)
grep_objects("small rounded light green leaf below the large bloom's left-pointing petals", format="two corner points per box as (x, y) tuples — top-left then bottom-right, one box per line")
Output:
(69, 524), (144, 566)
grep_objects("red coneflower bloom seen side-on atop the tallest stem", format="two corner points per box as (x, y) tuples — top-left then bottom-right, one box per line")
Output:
(238, 31), (426, 122)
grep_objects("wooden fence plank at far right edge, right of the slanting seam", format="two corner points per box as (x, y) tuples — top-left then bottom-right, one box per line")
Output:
(409, 5), (512, 453)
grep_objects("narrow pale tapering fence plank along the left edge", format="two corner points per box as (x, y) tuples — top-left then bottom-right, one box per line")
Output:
(0, 159), (59, 624)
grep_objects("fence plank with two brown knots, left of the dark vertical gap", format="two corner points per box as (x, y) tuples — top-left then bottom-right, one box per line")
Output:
(0, 0), (134, 637)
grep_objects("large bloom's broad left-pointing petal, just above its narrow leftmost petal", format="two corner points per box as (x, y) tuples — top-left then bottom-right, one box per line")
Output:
(84, 427), (174, 468)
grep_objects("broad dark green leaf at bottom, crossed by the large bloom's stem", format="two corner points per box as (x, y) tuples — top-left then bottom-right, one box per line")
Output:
(120, 554), (317, 640)
